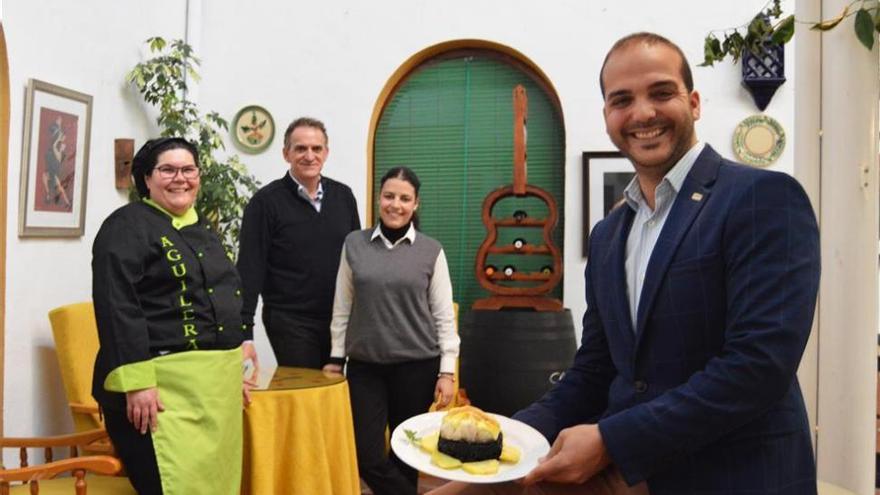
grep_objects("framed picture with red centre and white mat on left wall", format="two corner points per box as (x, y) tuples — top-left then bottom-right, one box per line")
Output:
(18, 79), (92, 237)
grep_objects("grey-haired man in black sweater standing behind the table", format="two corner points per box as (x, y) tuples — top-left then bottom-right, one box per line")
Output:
(238, 117), (361, 369)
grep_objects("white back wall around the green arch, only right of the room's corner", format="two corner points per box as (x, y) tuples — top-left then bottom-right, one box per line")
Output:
(192, 0), (794, 366)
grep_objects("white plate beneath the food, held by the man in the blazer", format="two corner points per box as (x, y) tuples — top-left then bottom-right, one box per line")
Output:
(391, 411), (550, 483)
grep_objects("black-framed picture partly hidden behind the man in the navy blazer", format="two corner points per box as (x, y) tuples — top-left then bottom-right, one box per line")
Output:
(582, 151), (635, 257)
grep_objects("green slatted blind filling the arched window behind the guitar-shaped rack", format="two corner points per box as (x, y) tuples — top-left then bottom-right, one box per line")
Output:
(372, 54), (565, 310)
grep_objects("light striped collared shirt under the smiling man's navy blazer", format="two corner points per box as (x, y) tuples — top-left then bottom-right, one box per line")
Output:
(623, 142), (705, 330)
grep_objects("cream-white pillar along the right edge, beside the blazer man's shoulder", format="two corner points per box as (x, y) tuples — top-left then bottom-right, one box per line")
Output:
(816, 0), (880, 493)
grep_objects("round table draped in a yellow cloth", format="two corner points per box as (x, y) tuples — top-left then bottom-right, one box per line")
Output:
(242, 368), (360, 495)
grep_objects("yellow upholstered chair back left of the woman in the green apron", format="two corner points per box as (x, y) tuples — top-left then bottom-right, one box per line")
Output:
(49, 302), (112, 453)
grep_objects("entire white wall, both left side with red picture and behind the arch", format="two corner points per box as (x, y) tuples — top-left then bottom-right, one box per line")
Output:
(3, 0), (794, 446)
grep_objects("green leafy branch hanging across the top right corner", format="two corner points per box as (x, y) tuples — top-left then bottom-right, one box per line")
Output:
(700, 0), (880, 67)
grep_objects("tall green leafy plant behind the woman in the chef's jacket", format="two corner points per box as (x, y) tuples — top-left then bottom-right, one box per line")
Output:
(126, 37), (259, 256)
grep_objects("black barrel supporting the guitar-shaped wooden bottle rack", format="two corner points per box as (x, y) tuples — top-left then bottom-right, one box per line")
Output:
(459, 309), (577, 416)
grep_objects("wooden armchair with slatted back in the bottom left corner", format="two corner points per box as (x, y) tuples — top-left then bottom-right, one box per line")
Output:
(0, 429), (136, 495)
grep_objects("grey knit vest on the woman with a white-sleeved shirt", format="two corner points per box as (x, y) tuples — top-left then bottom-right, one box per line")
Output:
(345, 229), (441, 363)
